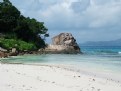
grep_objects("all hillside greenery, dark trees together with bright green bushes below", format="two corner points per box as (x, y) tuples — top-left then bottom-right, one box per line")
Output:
(0, 0), (49, 50)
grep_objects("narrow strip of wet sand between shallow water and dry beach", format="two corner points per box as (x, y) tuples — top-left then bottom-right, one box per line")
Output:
(0, 62), (121, 83)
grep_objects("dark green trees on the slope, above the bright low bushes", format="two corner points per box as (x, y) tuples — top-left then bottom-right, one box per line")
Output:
(0, 0), (49, 48)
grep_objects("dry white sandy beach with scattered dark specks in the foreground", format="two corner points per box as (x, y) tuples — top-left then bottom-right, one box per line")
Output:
(0, 64), (121, 91)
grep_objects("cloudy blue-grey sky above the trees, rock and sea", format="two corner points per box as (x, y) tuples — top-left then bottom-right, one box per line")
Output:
(0, 0), (121, 43)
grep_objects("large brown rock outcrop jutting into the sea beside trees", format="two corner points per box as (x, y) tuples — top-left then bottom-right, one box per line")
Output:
(46, 33), (81, 53)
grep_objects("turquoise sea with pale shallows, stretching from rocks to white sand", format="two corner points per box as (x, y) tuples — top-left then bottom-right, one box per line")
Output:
(0, 46), (121, 82)
